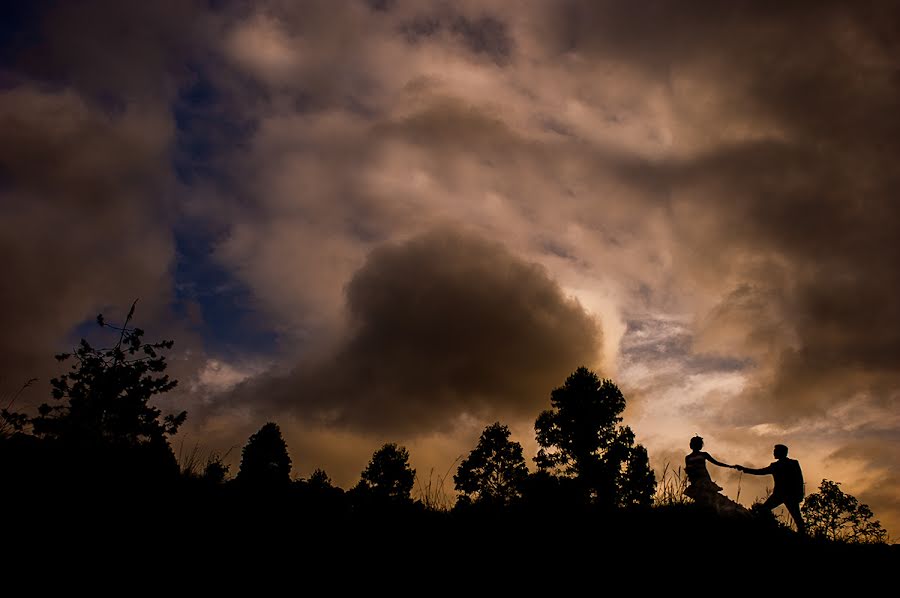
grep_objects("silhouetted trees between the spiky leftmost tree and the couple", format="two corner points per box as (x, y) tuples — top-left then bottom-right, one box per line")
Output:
(214, 367), (656, 509)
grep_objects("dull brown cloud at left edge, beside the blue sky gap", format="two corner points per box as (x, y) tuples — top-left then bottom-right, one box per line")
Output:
(0, 87), (173, 400)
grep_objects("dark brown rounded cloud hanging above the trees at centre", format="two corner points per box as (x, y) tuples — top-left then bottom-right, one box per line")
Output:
(229, 228), (600, 434)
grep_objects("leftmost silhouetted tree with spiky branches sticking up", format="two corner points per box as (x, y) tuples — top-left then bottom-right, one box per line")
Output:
(30, 302), (187, 482)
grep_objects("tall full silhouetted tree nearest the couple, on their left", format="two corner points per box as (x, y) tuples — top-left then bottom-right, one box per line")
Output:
(534, 367), (656, 506)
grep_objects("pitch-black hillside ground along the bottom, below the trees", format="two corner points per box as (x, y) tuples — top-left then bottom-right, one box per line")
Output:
(0, 489), (900, 596)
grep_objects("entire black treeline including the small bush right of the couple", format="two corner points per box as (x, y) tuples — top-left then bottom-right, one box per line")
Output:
(0, 306), (886, 560)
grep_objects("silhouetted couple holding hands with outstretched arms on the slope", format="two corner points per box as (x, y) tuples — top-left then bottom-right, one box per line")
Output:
(684, 436), (806, 534)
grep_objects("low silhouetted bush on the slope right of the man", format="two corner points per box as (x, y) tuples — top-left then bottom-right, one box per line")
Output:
(800, 480), (887, 544)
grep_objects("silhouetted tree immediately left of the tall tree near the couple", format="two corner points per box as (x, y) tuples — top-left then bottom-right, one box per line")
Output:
(453, 422), (528, 505)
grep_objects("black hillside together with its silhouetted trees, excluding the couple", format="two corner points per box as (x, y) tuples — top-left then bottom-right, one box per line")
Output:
(0, 354), (900, 596)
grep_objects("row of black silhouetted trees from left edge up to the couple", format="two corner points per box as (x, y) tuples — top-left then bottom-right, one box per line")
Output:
(0, 307), (656, 509)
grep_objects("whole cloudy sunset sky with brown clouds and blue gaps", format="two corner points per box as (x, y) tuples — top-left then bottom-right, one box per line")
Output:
(0, 0), (900, 537)
